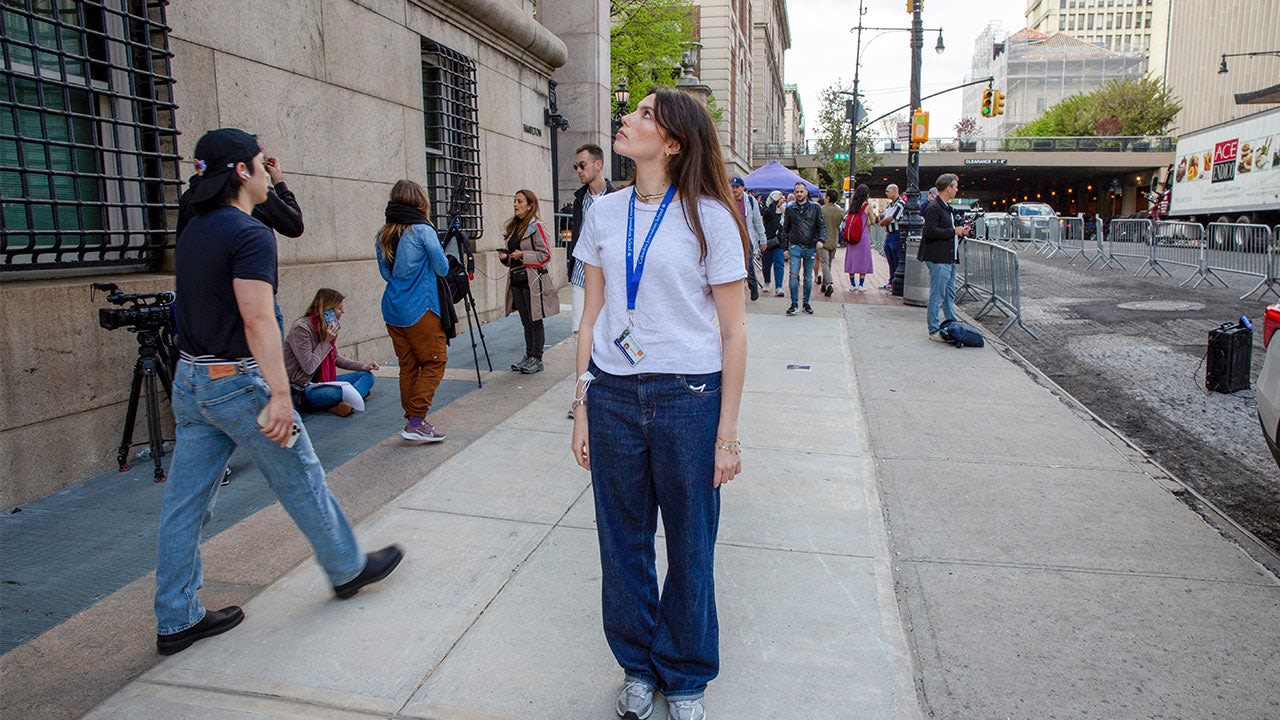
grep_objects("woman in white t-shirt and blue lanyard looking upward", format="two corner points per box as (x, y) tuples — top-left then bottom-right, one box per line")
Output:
(571, 90), (749, 720)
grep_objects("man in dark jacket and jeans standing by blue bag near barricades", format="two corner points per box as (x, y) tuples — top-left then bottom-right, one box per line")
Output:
(915, 173), (970, 342)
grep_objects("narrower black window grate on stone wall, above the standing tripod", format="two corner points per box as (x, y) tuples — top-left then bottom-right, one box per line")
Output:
(422, 38), (484, 240)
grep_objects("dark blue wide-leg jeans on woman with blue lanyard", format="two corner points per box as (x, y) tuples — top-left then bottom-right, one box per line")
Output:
(588, 364), (721, 700)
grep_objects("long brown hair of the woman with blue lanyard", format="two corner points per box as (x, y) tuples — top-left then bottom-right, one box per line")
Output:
(653, 88), (751, 260)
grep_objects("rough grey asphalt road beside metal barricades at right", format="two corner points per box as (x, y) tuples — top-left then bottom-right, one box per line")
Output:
(961, 249), (1280, 553)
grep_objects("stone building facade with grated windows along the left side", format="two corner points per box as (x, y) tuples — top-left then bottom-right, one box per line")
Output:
(0, 0), (611, 507)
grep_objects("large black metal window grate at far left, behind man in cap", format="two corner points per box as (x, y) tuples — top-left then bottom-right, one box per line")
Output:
(0, 0), (180, 274)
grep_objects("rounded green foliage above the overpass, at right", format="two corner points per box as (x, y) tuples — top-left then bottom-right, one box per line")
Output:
(1012, 78), (1181, 137)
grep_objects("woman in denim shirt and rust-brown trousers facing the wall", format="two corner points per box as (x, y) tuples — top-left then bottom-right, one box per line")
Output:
(374, 179), (449, 445)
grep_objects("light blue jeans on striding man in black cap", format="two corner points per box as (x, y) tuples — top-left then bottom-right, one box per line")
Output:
(155, 360), (365, 635)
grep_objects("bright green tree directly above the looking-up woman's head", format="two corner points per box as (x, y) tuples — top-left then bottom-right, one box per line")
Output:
(609, 0), (695, 95)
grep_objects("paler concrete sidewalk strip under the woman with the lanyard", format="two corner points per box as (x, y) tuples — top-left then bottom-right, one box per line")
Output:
(77, 292), (920, 719)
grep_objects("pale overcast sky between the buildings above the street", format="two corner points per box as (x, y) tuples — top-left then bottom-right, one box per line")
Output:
(786, 0), (1027, 138)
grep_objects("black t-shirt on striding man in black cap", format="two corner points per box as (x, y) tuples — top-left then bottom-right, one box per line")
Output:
(174, 205), (275, 360)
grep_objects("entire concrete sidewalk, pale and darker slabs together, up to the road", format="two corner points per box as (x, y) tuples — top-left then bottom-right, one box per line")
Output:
(4, 274), (1280, 720)
